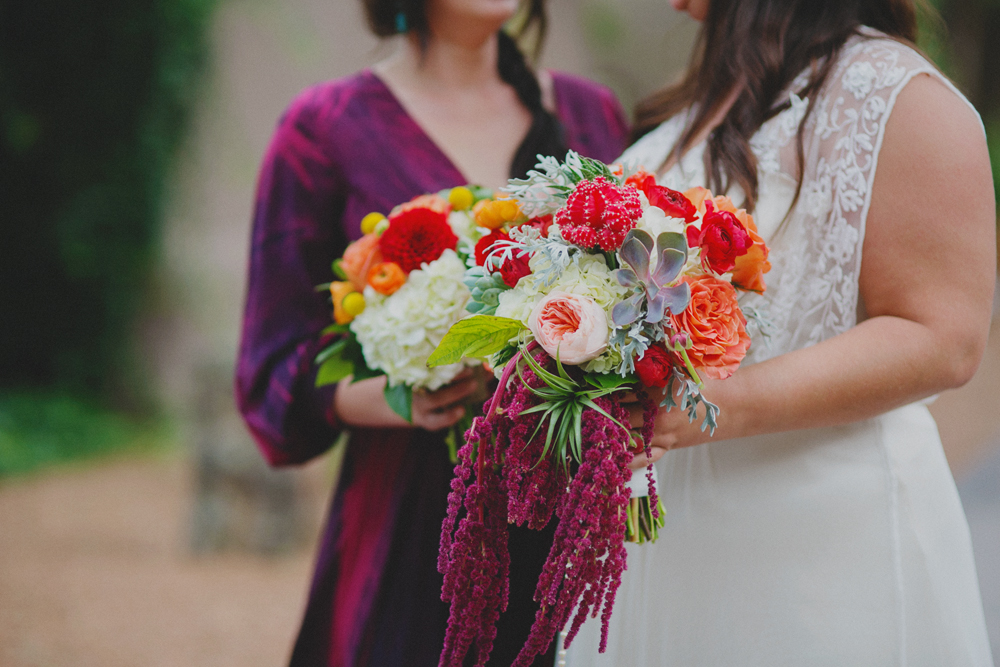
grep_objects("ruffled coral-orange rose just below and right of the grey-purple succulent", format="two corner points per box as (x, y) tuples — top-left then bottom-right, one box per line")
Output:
(670, 276), (750, 380)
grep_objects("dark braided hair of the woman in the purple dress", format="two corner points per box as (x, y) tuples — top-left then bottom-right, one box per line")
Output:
(362, 0), (566, 178)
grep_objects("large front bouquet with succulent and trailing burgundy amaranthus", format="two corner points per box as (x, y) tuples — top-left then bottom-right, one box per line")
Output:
(428, 152), (770, 666)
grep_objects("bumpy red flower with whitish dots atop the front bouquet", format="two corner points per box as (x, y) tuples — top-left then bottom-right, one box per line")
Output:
(555, 176), (642, 251)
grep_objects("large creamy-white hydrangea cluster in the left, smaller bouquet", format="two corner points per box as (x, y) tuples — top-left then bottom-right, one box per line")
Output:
(351, 250), (479, 391)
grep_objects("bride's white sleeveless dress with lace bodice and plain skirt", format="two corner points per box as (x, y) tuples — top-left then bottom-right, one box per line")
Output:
(564, 31), (993, 667)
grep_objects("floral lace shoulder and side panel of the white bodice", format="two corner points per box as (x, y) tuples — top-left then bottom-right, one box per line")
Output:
(748, 37), (928, 361)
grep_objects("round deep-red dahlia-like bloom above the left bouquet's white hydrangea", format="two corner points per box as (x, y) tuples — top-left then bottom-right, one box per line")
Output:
(379, 208), (458, 274)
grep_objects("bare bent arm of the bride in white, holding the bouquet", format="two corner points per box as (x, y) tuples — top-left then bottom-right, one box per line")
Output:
(636, 76), (996, 464)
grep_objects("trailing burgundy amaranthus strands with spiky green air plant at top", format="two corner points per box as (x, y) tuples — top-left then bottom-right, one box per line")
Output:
(438, 344), (658, 667)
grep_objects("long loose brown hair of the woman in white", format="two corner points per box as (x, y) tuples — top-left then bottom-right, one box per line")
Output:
(633, 0), (925, 210)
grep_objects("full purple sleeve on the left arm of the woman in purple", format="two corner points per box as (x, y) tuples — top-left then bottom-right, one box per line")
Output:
(236, 87), (346, 465)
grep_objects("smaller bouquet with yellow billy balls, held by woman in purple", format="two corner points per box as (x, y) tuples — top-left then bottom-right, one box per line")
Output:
(316, 186), (519, 421)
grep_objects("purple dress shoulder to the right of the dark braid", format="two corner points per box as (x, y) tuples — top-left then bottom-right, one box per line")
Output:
(549, 72), (629, 162)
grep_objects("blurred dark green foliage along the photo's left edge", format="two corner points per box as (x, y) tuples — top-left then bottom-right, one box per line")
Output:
(0, 0), (215, 476)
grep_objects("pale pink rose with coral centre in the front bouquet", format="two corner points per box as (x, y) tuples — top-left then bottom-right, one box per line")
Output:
(528, 292), (608, 366)
